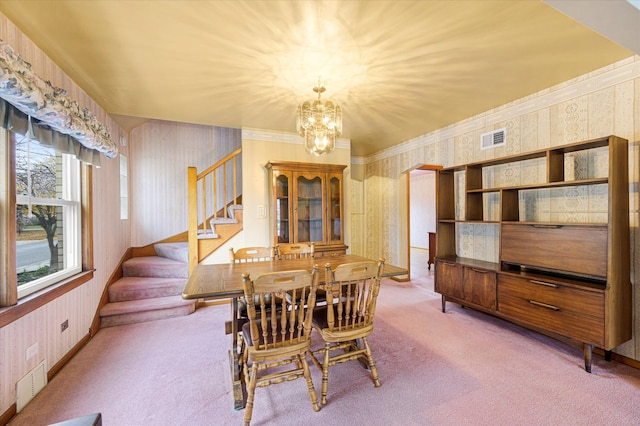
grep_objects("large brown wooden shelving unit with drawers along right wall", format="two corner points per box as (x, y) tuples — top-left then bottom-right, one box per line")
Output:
(435, 136), (632, 372)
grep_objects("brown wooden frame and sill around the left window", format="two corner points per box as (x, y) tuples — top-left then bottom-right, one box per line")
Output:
(0, 127), (94, 327)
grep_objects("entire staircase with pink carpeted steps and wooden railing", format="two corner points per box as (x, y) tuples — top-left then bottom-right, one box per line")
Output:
(100, 148), (242, 327)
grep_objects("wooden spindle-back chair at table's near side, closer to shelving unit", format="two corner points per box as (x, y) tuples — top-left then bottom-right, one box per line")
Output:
(311, 259), (384, 405)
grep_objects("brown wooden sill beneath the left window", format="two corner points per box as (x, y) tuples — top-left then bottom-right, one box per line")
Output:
(0, 270), (93, 328)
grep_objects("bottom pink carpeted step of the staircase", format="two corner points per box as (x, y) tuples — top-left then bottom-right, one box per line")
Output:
(100, 296), (196, 327)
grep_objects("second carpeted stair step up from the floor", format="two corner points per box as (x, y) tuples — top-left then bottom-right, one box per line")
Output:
(109, 277), (187, 302)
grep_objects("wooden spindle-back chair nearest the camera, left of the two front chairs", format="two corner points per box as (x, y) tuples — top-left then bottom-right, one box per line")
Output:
(242, 265), (320, 425)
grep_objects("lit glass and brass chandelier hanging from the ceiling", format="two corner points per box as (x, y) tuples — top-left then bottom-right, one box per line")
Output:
(296, 81), (342, 155)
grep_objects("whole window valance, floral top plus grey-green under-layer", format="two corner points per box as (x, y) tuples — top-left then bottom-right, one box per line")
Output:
(0, 40), (118, 164)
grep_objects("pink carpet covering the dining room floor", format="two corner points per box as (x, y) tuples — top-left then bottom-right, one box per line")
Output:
(10, 279), (640, 426)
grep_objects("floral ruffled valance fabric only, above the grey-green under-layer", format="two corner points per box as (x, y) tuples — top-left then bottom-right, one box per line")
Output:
(0, 40), (118, 158)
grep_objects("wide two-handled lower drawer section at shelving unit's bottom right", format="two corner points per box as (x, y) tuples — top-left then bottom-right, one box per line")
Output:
(498, 275), (604, 346)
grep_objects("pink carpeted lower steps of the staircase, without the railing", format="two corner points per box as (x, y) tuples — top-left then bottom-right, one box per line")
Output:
(100, 242), (196, 328)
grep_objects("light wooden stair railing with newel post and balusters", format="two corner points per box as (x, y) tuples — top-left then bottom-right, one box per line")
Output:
(188, 148), (242, 272)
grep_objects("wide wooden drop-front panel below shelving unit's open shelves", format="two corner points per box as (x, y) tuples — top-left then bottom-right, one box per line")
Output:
(500, 224), (607, 278)
